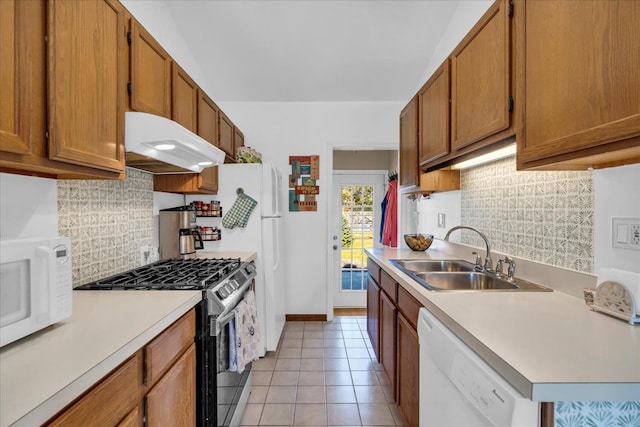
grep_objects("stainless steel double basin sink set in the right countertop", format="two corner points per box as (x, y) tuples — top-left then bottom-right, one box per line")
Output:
(389, 259), (551, 292)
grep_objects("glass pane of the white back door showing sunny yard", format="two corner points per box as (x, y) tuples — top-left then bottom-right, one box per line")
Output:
(341, 185), (373, 292)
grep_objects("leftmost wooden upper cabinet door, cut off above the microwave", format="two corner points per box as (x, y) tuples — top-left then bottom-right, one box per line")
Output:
(0, 0), (46, 154)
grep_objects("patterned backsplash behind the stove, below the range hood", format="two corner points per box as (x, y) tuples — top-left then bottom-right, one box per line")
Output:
(58, 168), (153, 287)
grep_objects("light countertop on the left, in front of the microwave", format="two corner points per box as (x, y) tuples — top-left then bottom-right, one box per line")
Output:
(0, 291), (202, 427)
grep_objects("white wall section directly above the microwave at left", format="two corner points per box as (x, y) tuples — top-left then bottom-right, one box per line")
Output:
(0, 173), (58, 240)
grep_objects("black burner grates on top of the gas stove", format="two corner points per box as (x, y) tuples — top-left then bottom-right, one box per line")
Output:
(76, 258), (241, 290)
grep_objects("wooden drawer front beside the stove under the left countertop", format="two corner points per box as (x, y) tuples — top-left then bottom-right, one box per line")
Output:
(144, 310), (196, 387)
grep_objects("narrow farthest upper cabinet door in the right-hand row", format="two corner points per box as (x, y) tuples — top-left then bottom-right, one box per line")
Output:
(399, 97), (420, 185)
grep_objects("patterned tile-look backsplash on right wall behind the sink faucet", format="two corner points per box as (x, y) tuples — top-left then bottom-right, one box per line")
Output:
(460, 156), (594, 273)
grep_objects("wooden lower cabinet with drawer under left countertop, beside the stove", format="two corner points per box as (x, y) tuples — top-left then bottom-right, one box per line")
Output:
(44, 310), (196, 427)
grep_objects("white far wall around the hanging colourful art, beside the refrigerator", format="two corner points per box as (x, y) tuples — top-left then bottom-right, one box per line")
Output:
(221, 102), (402, 314)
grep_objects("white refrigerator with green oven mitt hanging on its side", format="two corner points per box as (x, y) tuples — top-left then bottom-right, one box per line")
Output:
(192, 163), (285, 351)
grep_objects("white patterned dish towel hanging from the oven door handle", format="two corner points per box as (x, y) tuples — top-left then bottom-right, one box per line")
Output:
(233, 290), (260, 373)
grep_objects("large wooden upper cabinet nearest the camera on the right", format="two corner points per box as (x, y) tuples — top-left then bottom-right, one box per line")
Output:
(515, 0), (640, 169)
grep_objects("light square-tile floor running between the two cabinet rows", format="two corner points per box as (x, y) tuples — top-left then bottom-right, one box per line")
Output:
(241, 316), (403, 426)
